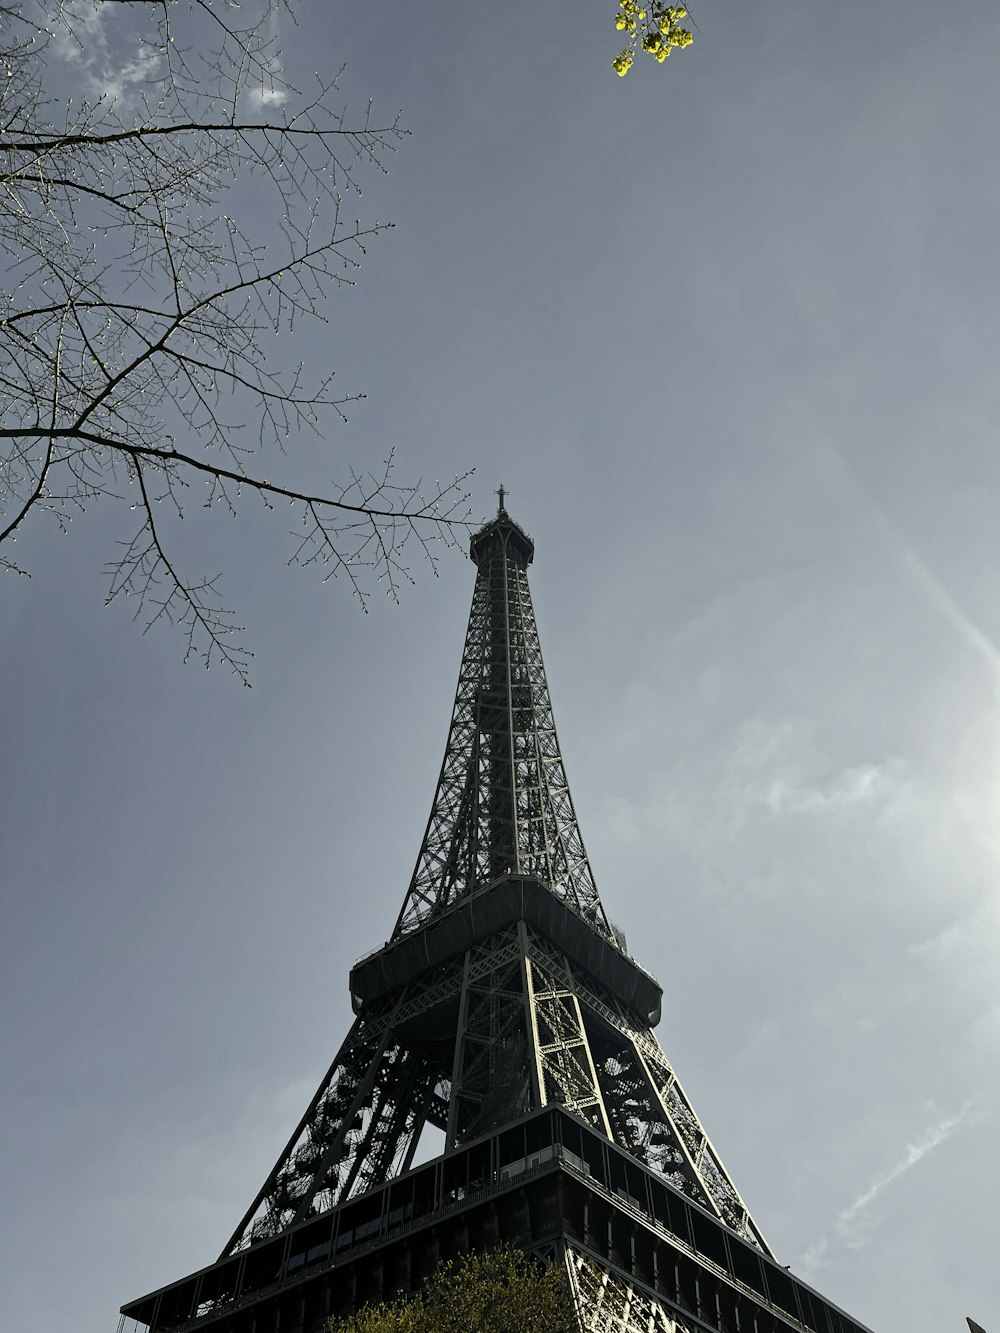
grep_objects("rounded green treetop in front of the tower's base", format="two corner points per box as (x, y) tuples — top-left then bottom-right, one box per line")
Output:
(327, 1246), (577, 1333)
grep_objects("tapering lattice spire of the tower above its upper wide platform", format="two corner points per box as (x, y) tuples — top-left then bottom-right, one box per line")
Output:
(393, 513), (613, 938)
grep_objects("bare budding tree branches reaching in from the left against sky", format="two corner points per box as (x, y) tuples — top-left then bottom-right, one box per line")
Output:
(0, 0), (468, 680)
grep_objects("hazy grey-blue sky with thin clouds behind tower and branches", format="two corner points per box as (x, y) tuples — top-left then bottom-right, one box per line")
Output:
(0, 0), (1000, 1333)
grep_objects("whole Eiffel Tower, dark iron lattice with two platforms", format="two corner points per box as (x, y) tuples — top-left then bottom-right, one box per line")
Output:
(119, 501), (865, 1333)
